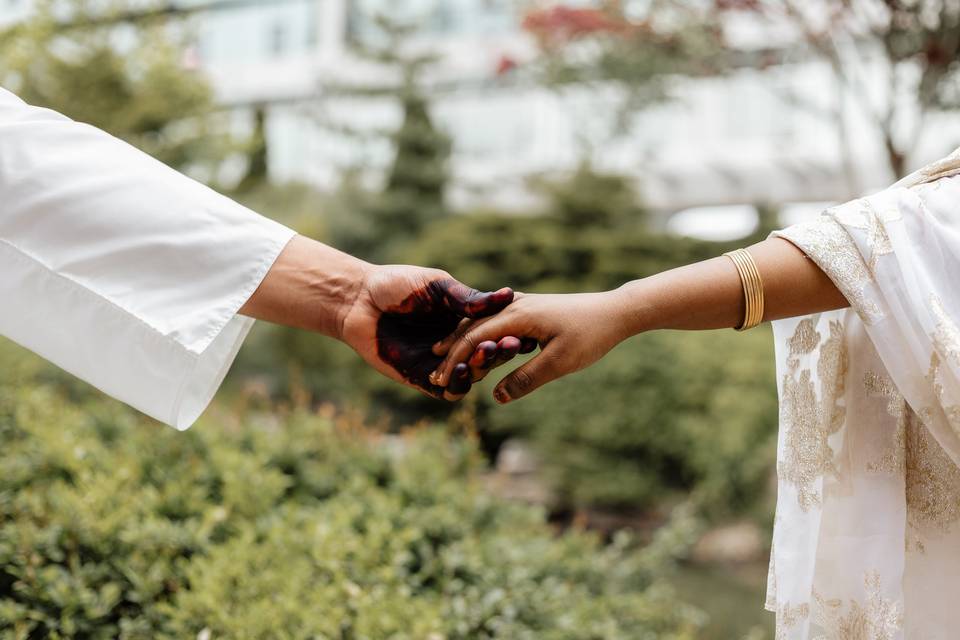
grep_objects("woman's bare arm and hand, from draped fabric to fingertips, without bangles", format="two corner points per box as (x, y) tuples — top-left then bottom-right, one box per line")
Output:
(432, 239), (848, 403)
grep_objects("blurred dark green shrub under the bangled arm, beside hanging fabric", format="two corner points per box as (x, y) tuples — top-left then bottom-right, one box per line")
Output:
(487, 331), (777, 517)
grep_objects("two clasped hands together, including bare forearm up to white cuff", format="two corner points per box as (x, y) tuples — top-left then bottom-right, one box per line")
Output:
(240, 236), (635, 403)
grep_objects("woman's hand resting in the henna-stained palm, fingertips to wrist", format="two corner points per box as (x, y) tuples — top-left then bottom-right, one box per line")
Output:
(431, 292), (631, 404)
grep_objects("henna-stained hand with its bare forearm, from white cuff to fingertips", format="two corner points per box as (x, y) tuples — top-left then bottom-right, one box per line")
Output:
(240, 236), (520, 400)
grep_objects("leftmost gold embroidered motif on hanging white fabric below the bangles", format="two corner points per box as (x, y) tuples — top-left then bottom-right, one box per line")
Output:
(778, 320), (847, 511)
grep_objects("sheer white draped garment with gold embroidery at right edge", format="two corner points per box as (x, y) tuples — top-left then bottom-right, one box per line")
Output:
(767, 155), (960, 640)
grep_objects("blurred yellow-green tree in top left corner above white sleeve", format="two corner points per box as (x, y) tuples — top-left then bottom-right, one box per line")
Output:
(0, 0), (230, 169)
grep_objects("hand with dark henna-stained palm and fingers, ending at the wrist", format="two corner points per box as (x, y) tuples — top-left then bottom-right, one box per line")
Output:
(341, 266), (517, 400)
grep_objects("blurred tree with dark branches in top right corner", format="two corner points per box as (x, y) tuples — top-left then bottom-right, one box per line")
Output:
(714, 0), (960, 177)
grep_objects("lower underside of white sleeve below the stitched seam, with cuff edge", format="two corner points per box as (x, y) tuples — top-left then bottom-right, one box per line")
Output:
(0, 231), (294, 430)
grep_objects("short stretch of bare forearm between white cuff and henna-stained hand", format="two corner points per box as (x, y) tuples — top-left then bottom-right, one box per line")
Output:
(240, 236), (370, 338)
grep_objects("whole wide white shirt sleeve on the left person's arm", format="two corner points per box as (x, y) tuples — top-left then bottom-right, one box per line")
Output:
(0, 89), (294, 429)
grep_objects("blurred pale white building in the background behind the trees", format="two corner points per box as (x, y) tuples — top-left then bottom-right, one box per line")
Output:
(7, 0), (960, 239)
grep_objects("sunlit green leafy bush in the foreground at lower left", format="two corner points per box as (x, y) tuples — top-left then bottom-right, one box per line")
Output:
(0, 352), (701, 640)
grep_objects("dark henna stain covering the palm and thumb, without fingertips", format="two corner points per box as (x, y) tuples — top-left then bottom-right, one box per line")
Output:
(377, 279), (513, 398)
